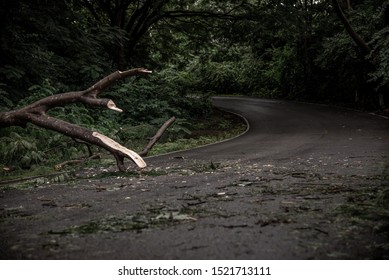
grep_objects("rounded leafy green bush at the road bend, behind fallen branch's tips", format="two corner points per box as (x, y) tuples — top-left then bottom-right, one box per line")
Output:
(105, 69), (211, 125)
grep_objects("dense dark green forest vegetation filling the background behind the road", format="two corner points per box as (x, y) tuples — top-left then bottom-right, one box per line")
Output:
(0, 0), (389, 171)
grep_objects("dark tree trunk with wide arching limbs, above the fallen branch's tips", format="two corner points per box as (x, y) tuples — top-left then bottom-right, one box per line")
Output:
(78, 0), (241, 69)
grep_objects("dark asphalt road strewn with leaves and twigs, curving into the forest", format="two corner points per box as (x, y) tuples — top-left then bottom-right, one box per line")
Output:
(0, 97), (389, 259)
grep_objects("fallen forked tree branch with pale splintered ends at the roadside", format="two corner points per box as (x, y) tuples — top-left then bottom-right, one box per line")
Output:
(0, 68), (151, 171)
